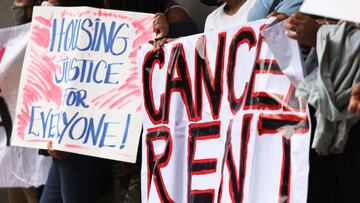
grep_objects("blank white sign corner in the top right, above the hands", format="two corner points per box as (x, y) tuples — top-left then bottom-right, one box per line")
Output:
(300, 0), (360, 23)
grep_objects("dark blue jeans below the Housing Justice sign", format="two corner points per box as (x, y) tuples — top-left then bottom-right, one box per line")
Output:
(40, 154), (110, 203)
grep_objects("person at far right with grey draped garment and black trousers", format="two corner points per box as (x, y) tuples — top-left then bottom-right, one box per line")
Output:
(284, 10), (360, 203)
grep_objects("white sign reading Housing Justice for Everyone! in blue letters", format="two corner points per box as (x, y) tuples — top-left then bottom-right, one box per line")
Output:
(12, 7), (152, 162)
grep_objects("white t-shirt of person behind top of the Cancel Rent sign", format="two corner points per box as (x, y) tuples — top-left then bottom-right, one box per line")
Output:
(204, 0), (256, 32)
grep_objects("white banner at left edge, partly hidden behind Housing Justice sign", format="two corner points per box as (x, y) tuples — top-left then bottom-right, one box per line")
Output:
(0, 24), (51, 187)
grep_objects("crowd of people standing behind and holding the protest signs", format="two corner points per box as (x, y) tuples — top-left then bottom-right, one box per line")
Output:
(3, 0), (360, 203)
